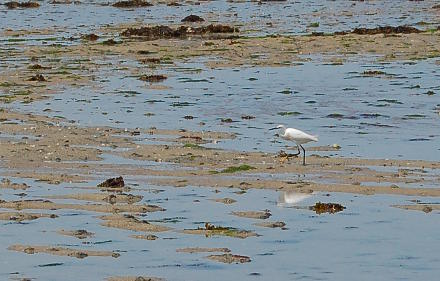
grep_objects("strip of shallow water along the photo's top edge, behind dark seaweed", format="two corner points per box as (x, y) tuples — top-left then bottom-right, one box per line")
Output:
(0, 0), (439, 37)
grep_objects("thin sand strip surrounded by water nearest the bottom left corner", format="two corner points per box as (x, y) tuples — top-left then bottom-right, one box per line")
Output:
(8, 244), (120, 259)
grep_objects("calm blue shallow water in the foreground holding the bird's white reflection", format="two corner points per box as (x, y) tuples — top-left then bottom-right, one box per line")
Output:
(0, 180), (440, 280)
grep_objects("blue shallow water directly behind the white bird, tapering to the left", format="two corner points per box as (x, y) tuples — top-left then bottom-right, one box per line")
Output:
(13, 58), (440, 160)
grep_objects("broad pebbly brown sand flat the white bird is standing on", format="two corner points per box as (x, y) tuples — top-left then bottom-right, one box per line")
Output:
(0, 108), (440, 196)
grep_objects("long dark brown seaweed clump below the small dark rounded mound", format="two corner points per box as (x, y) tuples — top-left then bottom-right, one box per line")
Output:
(121, 24), (239, 40)
